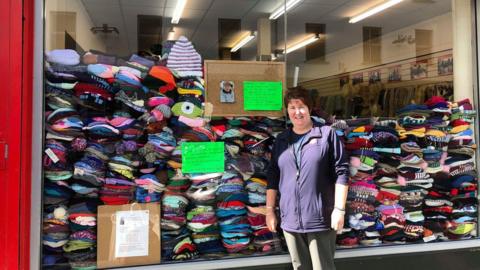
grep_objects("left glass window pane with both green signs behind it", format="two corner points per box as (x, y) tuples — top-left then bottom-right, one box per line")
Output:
(42, 0), (286, 269)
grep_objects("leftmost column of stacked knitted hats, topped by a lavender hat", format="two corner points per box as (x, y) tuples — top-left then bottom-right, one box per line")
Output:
(43, 50), (98, 267)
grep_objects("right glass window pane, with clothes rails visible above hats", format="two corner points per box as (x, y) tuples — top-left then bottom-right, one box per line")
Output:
(287, 0), (478, 248)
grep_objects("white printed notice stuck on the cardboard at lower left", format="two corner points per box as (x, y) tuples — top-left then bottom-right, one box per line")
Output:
(115, 210), (149, 258)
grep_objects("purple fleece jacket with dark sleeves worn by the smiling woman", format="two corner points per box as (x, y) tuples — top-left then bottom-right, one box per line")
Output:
(267, 122), (349, 233)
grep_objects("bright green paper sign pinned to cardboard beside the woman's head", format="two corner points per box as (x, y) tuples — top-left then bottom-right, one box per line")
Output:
(243, 81), (282, 111)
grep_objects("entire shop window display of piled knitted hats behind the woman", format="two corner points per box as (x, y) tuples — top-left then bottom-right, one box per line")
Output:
(39, 0), (478, 269)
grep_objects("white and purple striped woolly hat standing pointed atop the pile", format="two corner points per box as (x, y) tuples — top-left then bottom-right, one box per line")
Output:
(167, 36), (203, 77)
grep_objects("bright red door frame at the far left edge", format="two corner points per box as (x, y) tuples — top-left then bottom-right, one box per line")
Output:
(0, 0), (34, 270)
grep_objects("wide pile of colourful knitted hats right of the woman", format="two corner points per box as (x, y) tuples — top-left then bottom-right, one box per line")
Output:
(332, 94), (478, 247)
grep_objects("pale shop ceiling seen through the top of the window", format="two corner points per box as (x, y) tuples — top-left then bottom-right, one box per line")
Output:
(76, 0), (451, 60)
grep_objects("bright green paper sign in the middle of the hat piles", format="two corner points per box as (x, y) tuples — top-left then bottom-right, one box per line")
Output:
(181, 142), (225, 173)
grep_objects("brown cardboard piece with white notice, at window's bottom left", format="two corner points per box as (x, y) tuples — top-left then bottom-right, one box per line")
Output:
(97, 203), (161, 268)
